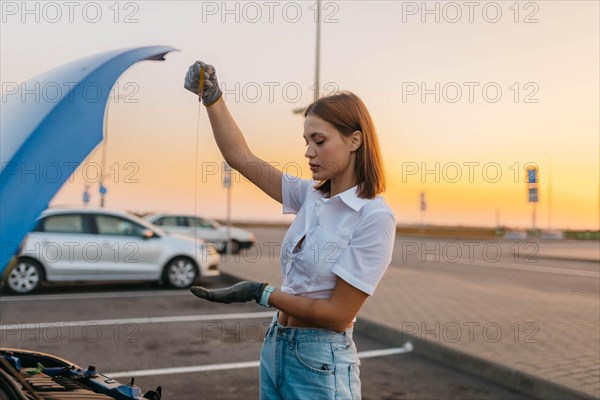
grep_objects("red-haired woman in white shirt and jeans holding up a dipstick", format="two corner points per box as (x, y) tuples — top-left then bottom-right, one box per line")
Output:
(184, 61), (396, 400)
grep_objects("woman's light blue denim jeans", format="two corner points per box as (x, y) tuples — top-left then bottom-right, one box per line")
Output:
(260, 314), (361, 400)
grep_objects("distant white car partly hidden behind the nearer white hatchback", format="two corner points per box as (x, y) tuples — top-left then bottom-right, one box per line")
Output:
(144, 214), (256, 254)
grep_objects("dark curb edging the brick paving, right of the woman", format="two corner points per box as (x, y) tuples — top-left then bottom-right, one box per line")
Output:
(354, 316), (598, 400)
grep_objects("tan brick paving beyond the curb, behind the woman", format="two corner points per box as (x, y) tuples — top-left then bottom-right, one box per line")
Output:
(222, 233), (600, 397)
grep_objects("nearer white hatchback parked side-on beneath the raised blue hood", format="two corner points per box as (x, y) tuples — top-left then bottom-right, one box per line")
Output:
(7, 207), (221, 293)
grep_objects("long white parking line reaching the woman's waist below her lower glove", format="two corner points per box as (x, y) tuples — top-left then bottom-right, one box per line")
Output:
(0, 311), (275, 331)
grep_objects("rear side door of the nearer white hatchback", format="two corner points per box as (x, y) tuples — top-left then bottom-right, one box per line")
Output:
(22, 213), (97, 280)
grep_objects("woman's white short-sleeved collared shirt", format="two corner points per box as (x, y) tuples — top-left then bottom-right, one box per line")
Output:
(281, 174), (396, 299)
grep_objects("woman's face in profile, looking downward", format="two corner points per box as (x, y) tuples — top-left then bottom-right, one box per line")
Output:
(304, 114), (354, 181)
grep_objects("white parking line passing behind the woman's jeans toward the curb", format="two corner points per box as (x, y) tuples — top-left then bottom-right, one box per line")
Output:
(103, 342), (413, 378)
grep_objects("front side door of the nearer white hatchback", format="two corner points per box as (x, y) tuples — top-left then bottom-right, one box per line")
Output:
(94, 214), (163, 280)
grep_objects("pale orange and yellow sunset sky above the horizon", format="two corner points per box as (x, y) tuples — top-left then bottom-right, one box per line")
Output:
(0, 1), (600, 229)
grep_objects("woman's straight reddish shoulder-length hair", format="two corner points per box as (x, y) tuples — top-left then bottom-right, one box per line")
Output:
(304, 91), (385, 199)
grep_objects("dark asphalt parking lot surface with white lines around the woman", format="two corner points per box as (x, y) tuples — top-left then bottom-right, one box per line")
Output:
(0, 276), (529, 400)
